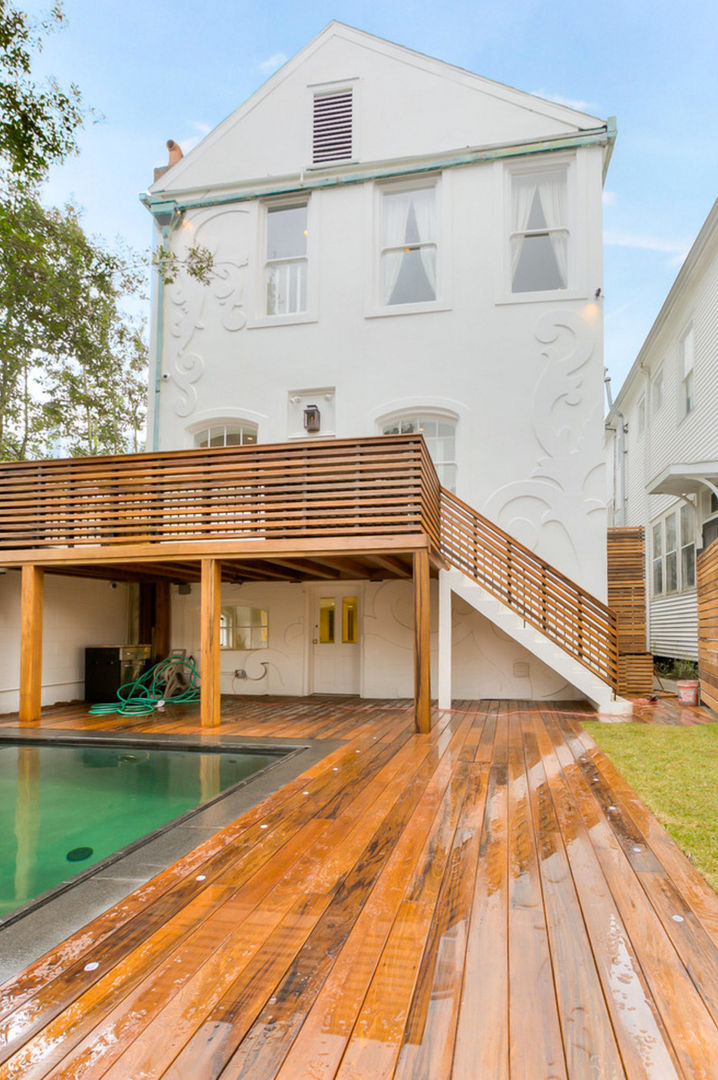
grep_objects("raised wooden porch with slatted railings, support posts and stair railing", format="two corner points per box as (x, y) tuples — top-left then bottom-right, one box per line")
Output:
(0, 435), (618, 732)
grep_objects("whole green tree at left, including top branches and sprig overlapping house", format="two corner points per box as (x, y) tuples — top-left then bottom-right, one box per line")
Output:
(0, 0), (212, 459)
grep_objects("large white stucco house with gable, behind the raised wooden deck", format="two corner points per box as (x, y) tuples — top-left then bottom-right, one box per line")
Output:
(0, 23), (615, 708)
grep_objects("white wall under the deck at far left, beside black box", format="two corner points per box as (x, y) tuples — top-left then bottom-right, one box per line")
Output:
(0, 570), (130, 714)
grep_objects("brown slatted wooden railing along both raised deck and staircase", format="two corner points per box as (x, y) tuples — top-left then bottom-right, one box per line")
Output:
(0, 435), (618, 686)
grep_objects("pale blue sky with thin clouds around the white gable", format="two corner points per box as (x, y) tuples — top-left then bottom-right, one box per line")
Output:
(21, 0), (718, 392)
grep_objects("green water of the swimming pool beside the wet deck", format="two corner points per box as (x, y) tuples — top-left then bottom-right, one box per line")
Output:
(0, 743), (276, 918)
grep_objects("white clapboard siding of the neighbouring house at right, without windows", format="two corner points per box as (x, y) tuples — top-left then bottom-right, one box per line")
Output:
(606, 204), (718, 660)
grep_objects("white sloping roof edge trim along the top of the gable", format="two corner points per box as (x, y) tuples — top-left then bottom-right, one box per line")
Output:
(149, 21), (605, 193)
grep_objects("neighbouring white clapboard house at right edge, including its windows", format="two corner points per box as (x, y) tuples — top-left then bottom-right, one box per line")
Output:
(606, 202), (718, 660)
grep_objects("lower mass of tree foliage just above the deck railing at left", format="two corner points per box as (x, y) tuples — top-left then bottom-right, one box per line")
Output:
(0, 177), (147, 459)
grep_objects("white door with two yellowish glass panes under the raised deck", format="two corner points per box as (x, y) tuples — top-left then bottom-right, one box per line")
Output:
(312, 584), (360, 693)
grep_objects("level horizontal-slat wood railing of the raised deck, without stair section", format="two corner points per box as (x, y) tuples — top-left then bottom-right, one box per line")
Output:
(0, 435), (439, 551)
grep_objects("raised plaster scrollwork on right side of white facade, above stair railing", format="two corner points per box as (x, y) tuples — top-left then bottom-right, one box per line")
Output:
(484, 311), (606, 577)
